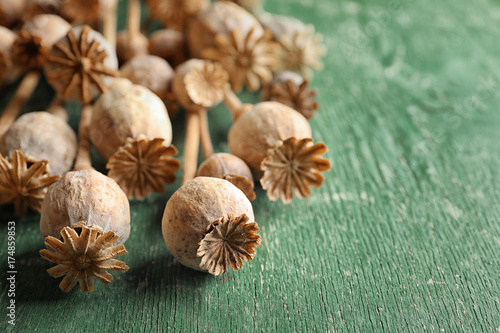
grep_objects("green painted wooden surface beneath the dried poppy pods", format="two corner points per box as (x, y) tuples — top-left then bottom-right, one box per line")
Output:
(0, 0), (500, 332)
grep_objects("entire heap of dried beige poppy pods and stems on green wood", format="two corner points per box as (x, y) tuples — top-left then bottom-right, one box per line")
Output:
(0, 0), (330, 292)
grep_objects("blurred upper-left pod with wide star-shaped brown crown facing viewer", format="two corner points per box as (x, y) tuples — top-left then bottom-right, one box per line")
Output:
(44, 25), (119, 104)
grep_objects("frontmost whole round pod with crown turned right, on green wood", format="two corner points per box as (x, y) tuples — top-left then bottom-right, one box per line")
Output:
(162, 177), (260, 275)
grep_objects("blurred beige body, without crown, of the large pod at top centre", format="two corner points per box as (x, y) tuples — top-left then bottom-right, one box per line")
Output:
(187, 1), (264, 58)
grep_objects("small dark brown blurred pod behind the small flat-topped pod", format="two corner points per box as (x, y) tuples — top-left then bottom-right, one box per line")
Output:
(149, 29), (188, 68)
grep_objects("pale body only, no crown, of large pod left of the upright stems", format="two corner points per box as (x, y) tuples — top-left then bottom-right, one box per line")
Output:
(90, 79), (172, 160)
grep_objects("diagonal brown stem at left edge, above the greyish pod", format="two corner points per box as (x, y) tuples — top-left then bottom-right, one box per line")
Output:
(0, 71), (40, 138)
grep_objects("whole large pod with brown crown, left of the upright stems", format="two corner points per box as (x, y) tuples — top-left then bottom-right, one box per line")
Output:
(90, 79), (180, 199)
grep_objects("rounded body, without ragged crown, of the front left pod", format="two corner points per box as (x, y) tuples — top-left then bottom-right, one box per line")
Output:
(40, 170), (130, 244)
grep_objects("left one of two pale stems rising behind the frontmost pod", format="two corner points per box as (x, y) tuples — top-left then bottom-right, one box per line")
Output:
(182, 111), (201, 185)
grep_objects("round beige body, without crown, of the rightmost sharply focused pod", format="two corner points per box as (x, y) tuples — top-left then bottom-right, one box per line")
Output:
(228, 102), (312, 178)
